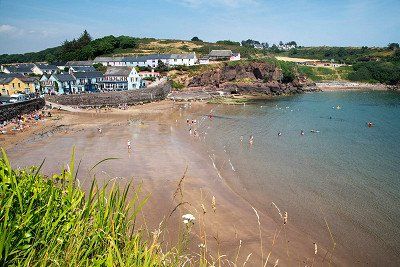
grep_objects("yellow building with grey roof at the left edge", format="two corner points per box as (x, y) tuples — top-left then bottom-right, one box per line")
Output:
(0, 77), (36, 95)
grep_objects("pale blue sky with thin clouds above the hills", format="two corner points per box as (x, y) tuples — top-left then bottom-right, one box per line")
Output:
(0, 0), (400, 54)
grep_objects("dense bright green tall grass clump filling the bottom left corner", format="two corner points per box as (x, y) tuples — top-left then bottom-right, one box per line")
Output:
(0, 151), (169, 266)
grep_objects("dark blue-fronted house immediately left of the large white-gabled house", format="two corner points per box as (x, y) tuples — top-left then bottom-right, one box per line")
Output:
(72, 71), (103, 93)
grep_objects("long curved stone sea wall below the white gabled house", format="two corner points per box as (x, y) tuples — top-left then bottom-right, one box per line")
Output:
(46, 82), (172, 107)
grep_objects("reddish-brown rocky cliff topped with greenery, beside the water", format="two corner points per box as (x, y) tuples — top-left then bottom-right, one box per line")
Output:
(188, 62), (318, 94)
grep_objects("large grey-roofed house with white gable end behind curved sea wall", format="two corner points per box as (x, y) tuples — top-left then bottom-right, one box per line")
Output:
(100, 66), (141, 91)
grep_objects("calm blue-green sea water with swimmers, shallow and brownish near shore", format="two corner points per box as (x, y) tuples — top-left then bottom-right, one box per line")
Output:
(191, 91), (400, 266)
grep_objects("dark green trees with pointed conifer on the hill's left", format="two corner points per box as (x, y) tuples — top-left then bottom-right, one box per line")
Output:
(0, 30), (140, 64)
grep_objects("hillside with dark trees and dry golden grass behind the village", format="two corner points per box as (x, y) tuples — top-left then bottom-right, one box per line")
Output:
(0, 31), (263, 64)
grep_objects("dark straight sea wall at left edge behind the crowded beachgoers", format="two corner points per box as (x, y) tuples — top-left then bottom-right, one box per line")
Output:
(0, 98), (45, 122)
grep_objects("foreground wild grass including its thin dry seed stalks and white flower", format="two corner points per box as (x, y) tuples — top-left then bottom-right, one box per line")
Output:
(0, 151), (336, 267)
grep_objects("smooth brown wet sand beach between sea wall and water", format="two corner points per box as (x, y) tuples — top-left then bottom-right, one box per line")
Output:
(0, 101), (351, 266)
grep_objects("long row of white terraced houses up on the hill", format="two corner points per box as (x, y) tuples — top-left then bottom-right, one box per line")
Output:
(94, 53), (197, 68)
